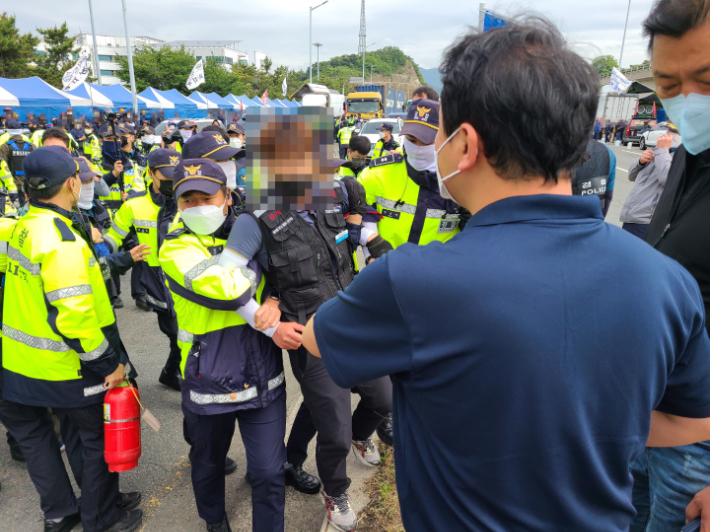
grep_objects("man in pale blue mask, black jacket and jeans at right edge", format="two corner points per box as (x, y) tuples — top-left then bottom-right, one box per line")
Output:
(631, 0), (710, 532)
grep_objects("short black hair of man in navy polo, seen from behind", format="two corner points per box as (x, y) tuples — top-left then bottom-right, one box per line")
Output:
(440, 17), (599, 183)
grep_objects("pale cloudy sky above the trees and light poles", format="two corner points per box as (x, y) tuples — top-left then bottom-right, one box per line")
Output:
(9, 0), (652, 69)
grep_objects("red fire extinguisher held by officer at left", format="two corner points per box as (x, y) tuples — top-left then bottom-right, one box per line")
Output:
(104, 383), (141, 473)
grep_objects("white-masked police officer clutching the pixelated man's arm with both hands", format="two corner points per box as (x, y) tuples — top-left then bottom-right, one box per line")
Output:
(160, 158), (286, 532)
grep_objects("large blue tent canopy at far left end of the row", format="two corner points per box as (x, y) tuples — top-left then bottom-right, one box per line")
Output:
(0, 77), (91, 121)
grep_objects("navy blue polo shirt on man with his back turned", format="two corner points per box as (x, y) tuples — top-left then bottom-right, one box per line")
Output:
(315, 195), (710, 532)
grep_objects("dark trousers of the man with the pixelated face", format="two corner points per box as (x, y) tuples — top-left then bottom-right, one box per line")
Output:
(286, 347), (392, 497)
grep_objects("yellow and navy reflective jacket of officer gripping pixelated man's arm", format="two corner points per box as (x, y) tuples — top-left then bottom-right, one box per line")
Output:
(160, 214), (285, 414)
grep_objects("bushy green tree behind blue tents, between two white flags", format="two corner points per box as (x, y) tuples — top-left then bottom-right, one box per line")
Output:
(116, 45), (196, 94)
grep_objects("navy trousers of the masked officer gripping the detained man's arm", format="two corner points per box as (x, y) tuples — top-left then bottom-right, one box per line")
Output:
(182, 391), (286, 532)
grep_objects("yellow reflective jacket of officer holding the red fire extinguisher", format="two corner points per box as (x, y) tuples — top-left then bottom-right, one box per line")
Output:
(2, 200), (128, 408)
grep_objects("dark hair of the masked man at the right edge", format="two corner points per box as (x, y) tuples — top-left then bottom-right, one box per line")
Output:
(643, 0), (710, 52)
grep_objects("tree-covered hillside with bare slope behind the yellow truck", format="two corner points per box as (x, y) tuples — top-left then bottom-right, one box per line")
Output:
(291, 46), (425, 96)
